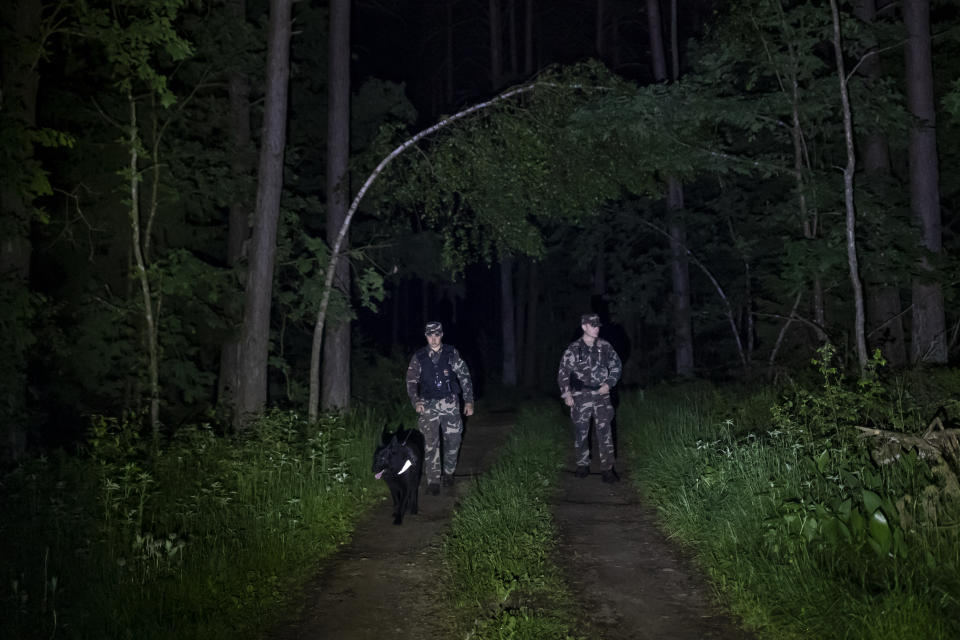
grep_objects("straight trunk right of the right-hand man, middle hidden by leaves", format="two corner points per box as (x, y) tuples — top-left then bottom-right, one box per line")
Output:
(647, 0), (693, 376)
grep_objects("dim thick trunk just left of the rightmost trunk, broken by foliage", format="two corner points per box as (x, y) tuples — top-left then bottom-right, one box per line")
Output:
(854, 0), (907, 367)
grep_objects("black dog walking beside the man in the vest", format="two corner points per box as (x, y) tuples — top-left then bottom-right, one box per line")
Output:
(373, 429), (423, 524)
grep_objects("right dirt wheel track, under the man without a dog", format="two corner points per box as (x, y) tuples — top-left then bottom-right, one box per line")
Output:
(553, 446), (753, 640)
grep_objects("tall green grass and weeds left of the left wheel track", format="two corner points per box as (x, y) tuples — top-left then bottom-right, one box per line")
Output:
(0, 411), (390, 639)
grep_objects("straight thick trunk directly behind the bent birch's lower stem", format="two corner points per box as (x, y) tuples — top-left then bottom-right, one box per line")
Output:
(321, 0), (350, 411)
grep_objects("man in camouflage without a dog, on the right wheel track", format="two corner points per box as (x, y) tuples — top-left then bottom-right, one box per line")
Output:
(557, 313), (622, 482)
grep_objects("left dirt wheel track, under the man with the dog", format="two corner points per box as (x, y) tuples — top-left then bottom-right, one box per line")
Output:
(266, 412), (514, 640)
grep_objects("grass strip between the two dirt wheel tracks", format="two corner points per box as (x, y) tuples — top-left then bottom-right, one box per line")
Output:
(443, 407), (576, 640)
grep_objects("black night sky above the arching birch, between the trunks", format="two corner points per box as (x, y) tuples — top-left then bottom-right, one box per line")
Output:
(352, 0), (709, 123)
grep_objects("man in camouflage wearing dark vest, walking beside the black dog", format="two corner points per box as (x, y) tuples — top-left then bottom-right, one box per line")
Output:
(407, 322), (473, 496)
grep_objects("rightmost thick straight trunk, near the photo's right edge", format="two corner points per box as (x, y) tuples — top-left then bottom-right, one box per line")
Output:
(902, 0), (947, 363)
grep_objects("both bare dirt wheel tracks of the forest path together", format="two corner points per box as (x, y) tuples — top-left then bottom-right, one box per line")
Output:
(265, 413), (751, 640)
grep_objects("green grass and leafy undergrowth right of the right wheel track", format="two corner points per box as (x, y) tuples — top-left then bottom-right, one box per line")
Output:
(619, 348), (960, 640)
